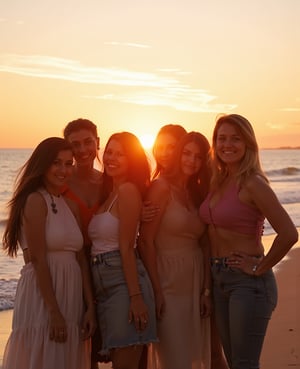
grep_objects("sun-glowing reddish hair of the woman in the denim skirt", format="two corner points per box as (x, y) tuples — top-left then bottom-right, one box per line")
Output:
(101, 132), (151, 201)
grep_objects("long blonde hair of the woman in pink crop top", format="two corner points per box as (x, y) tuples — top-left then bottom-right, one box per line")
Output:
(211, 114), (267, 190)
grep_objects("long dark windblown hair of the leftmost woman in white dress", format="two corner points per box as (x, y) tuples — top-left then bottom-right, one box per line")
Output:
(3, 137), (72, 256)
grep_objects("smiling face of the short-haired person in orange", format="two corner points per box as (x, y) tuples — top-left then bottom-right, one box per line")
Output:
(68, 129), (99, 167)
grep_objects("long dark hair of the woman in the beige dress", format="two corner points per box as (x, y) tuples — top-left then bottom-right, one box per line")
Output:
(162, 132), (211, 207)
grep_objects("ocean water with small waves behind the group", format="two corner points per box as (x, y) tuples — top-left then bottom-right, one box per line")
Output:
(0, 149), (300, 311)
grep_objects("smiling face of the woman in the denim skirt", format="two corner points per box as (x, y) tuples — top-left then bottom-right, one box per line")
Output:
(103, 139), (128, 182)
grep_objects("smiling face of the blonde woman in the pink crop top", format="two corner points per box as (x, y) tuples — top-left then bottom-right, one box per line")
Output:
(215, 123), (246, 167)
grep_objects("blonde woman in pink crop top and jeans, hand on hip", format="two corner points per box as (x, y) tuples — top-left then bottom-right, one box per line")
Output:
(200, 114), (298, 369)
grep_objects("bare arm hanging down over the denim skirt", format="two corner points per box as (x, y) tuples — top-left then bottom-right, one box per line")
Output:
(118, 183), (148, 330)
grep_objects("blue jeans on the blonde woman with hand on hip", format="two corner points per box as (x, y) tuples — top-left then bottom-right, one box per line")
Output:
(211, 263), (277, 369)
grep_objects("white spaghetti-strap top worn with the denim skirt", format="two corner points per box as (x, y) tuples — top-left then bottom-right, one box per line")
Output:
(88, 195), (136, 256)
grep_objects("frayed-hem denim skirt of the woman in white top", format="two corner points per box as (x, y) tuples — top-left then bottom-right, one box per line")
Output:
(91, 250), (158, 355)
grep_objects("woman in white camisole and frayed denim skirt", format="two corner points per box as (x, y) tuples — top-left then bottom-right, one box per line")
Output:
(88, 132), (157, 369)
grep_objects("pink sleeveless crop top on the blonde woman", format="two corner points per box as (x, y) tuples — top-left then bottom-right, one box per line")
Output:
(199, 184), (265, 236)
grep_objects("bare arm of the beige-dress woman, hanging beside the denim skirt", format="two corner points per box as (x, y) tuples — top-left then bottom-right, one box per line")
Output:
(139, 180), (169, 319)
